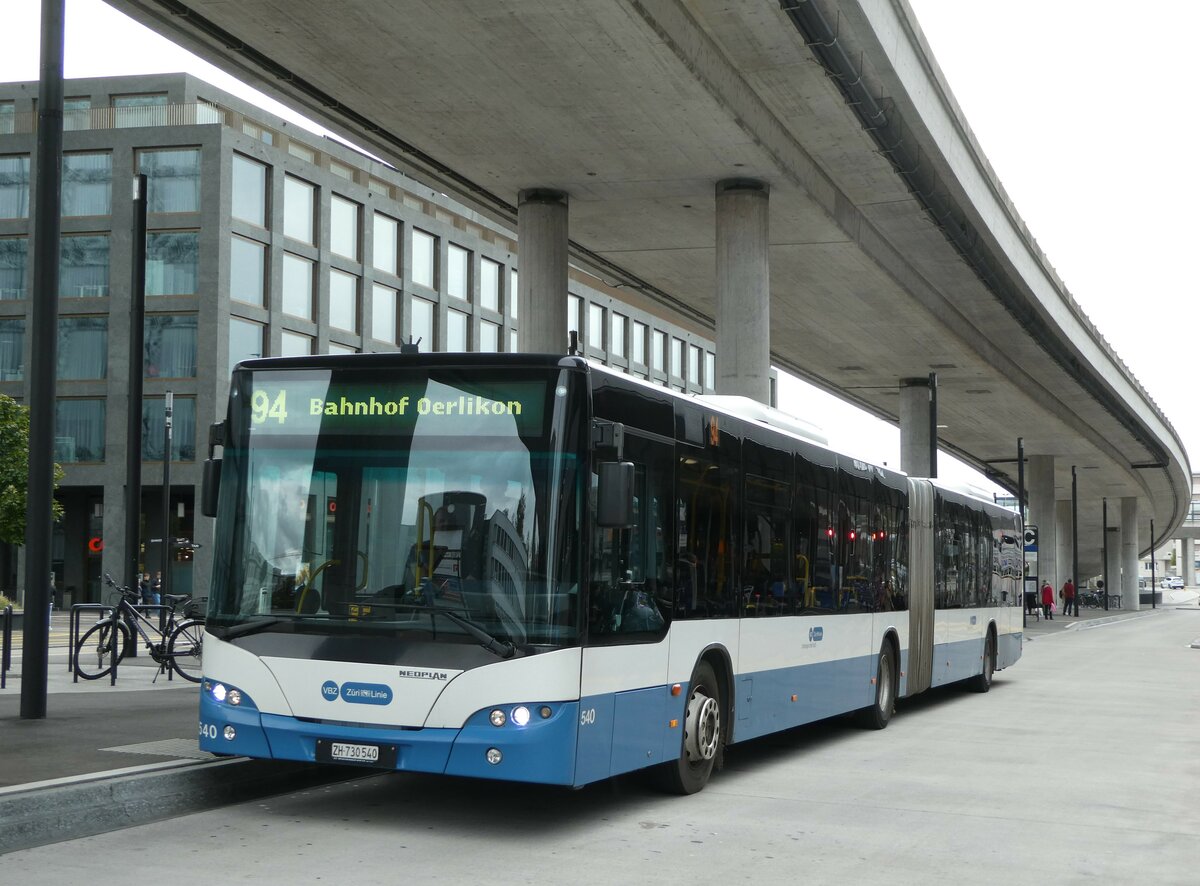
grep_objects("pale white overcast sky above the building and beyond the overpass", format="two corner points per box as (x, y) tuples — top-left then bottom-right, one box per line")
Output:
(7, 0), (1200, 475)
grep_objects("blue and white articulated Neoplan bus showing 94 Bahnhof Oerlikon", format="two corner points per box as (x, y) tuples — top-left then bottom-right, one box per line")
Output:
(199, 353), (1022, 794)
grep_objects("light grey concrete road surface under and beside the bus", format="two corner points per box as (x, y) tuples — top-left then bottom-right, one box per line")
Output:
(0, 609), (1200, 886)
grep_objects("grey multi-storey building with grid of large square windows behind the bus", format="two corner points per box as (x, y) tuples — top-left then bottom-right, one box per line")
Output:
(0, 74), (714, 604)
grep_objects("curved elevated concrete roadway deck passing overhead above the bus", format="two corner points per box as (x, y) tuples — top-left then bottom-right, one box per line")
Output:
(109, 0), (1190, 575)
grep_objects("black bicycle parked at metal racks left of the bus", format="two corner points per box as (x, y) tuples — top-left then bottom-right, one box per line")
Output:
(74, 573), (204, 683)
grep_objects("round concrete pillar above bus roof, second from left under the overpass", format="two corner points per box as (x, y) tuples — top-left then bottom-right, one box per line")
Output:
(716, 179), (770, 403)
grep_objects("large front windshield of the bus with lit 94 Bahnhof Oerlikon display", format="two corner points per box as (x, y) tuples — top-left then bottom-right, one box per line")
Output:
(209, 366), (586, 654)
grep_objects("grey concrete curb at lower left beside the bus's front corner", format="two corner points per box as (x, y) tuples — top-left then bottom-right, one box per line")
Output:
(0, 756), (362, 855)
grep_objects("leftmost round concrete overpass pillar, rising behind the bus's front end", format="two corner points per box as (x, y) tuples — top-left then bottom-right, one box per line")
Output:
(517, 188), (568, 354)
